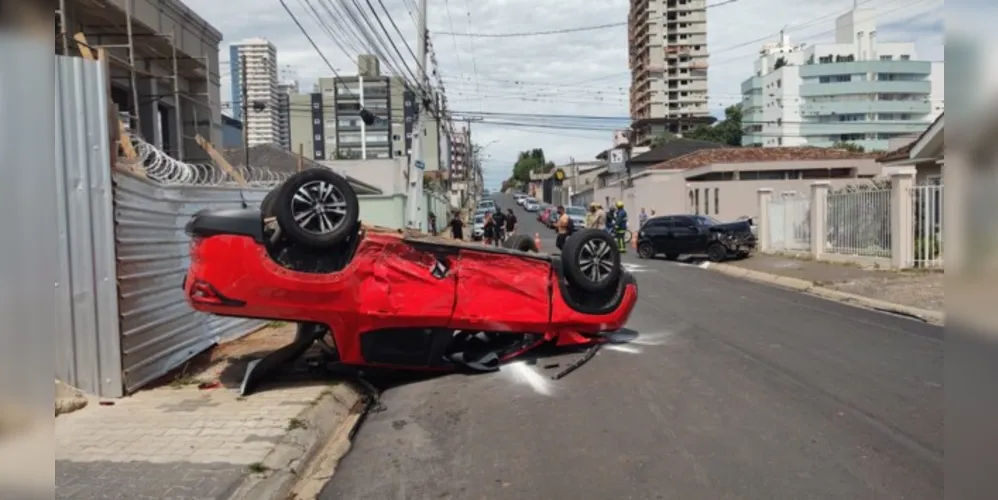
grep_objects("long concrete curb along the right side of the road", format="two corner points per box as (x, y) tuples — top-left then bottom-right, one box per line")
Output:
(706, 263), (946, 326)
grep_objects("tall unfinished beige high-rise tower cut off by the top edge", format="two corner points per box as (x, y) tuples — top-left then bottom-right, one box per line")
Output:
(628, 0), (714, 146)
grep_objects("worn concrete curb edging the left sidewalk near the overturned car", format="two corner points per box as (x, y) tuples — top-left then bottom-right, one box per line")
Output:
(227, 382), (366, 500)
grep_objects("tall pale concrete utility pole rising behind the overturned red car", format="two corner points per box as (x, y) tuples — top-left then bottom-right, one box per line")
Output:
(406, 0), (430, 229)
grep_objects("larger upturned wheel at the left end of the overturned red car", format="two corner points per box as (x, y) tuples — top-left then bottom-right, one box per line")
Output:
(274, 168), (360, 248)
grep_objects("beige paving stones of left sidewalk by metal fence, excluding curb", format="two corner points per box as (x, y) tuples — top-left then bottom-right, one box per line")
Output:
(55, 327), (350, 500)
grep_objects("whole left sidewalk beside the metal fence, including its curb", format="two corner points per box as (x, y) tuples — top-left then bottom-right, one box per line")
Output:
(55, 325), (361, 500)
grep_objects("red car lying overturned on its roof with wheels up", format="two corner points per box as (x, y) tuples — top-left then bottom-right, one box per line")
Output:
(183, 168), (638, 390)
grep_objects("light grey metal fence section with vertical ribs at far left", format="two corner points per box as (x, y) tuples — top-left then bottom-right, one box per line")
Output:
(55, 56), (122, 397)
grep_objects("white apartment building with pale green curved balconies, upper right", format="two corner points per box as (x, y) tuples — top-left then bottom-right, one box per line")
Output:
(741, 9), (944, 151)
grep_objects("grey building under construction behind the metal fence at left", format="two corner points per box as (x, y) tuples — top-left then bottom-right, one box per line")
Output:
(58, 0), (223, 163)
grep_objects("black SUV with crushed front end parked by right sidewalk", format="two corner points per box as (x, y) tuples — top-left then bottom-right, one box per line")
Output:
(638, 215), (755, 262)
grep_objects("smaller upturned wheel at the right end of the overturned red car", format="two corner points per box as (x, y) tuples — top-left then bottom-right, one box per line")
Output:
(561, 229), (621, 292)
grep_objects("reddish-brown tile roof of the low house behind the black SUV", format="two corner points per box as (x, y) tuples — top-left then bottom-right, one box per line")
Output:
(651, 147), (881, 170)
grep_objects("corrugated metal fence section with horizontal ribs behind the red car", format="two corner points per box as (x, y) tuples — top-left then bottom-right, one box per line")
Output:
(114, 172), (268, 392)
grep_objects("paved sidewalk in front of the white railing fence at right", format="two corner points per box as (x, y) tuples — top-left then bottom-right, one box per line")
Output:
(728, 254), (944, 311)
